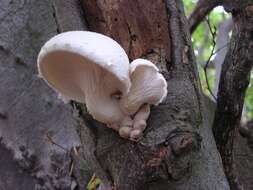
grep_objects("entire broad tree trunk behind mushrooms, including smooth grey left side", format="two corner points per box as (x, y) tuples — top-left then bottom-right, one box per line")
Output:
(0, 0), (229, 190)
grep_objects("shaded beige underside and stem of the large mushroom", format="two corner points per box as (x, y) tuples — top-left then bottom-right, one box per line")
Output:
(40, 51), (130, 124)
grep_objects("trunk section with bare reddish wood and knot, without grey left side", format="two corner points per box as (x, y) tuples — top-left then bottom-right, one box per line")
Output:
(73, 0), (229, 189)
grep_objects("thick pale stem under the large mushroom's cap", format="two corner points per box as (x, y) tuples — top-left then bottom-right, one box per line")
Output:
(80, 65), (125, 124)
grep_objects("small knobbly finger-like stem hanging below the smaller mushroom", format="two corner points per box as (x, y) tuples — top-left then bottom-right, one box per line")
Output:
(130, 104), (150, 141)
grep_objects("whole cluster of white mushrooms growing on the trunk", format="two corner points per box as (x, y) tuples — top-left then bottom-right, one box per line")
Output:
(38, 31), (167, 141)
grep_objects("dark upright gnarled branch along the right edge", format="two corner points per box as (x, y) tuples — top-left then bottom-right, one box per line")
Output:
(213, 1), (253, 189)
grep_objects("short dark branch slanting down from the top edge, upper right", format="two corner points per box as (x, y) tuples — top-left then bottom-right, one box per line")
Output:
(188, 0), (222, 33)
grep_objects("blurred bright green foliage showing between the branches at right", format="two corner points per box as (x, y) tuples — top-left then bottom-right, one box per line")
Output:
(183, 0), (253, 119)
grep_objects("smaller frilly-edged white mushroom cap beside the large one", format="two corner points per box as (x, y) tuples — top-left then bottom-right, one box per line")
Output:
(120, 59), (167, 115)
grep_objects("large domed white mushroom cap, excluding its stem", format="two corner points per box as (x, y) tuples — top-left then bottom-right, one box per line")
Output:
(38, 31), (130, 102)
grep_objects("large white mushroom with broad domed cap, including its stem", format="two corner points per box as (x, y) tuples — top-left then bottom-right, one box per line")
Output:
(38, 31), (131, 131)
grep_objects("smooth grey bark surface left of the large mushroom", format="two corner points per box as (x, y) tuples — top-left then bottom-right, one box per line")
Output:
(0, 0), (80, 190)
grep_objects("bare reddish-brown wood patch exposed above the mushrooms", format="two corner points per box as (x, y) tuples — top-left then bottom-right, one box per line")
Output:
(81, 0), (170, 70)
